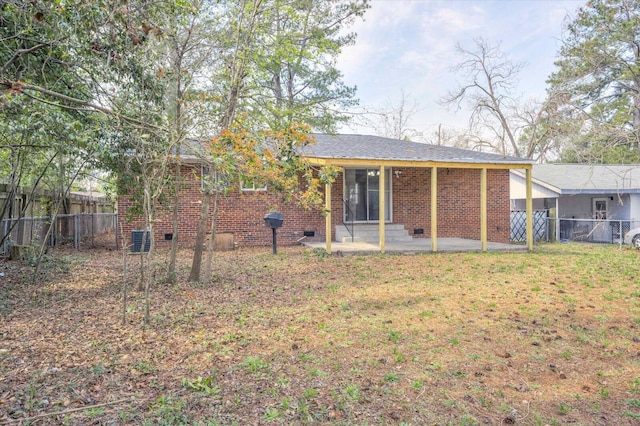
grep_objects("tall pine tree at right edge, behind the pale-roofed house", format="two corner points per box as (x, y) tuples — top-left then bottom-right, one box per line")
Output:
(549, 0), (640, 163)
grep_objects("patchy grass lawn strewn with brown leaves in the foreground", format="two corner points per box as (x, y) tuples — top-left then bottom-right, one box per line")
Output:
(0, 244), (640, 425)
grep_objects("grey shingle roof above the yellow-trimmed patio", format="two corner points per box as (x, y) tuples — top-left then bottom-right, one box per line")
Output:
(302, 134), (533, 165)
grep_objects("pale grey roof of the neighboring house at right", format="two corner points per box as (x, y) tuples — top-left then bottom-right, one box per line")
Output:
(532, 164), (640, 194)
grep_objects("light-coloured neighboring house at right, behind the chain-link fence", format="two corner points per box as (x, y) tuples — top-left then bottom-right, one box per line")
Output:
(511, 164), (640, 242)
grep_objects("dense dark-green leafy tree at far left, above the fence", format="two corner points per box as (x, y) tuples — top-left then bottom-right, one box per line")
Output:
(0, 0), (179, 302)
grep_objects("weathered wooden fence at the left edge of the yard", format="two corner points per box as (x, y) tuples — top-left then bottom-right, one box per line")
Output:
(0, 213), (116, 256)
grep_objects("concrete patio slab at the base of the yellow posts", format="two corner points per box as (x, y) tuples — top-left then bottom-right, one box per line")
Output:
(302, 238), (527, 254)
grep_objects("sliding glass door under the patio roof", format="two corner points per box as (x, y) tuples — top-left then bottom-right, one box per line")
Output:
(344, 168), (391, 222)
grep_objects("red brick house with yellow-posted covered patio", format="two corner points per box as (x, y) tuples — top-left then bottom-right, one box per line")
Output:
(118, 134), (532, 252)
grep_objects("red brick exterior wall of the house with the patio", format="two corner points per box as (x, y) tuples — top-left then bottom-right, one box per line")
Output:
(118, 165), (510, 247)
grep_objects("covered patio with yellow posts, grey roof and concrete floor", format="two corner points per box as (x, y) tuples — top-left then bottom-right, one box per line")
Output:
(301, 135), (533, 253)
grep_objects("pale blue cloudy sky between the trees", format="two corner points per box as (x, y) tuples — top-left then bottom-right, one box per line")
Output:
(337, 0), (586, 139)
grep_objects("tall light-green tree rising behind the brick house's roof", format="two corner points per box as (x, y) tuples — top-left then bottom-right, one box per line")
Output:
(247, 0), (369, 132)
